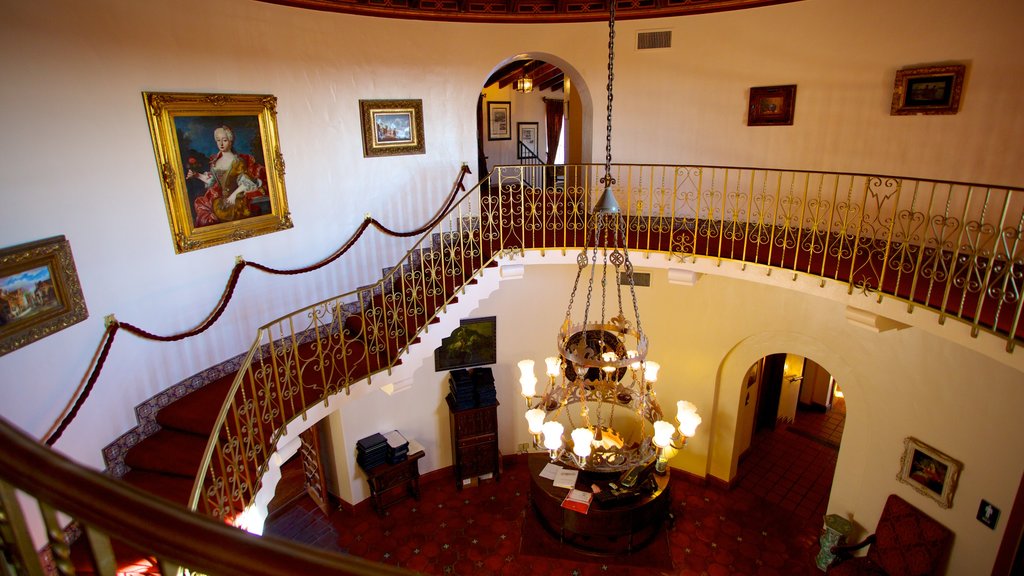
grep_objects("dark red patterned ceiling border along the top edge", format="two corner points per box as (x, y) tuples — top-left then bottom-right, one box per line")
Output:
(256, 0), (800, 24)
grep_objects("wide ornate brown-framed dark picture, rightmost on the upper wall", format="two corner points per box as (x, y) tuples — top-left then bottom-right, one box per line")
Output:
(890, 65), (967, 116)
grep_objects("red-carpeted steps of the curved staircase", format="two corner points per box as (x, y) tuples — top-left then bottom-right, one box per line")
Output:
(73, 219), (497, 574)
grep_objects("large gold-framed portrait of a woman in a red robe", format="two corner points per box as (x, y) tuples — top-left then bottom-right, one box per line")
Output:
(142, 92), (292, 254)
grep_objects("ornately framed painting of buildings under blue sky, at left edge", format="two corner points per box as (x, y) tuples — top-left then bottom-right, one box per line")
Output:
(0, 236), (89, 356)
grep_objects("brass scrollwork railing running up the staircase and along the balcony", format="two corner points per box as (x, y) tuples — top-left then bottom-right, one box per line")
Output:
(191, 165), (1024, 520)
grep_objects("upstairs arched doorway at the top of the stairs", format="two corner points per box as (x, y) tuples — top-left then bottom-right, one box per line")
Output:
(476, 53), (593, 178)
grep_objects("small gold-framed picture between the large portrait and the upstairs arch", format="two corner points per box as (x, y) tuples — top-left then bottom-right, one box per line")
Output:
(359, 100), (427, 158)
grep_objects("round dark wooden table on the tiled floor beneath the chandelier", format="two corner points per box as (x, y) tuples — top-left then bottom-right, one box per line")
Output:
(528, 453), (672, 554)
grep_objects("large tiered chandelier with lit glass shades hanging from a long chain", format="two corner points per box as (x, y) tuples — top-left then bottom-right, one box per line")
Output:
(519, 2), (700, 472)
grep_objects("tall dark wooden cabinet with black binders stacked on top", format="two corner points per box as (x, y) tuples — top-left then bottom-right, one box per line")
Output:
(445, 397), (501, 490)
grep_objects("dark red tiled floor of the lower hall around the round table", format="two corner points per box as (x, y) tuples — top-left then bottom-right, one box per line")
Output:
(265, 400), (845, 576)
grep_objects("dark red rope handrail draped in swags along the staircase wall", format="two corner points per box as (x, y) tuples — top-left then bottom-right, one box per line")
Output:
(44, 164), (471, 446)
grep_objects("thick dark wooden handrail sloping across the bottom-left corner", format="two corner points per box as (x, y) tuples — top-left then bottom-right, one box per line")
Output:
(0, 417), (412, 576)
